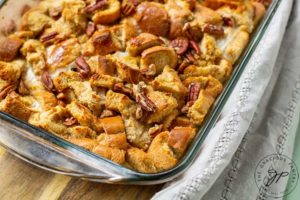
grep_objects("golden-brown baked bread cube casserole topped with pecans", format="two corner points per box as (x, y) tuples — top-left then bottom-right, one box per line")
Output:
(0, 0), (270, 173)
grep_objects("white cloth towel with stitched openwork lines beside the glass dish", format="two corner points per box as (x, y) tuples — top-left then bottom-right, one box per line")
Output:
(153, 0), (300, 200)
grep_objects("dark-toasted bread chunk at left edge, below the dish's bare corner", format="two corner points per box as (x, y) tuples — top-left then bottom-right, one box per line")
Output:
(0, 38), (22, 62)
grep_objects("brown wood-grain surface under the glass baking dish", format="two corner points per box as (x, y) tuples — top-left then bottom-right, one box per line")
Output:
(0, 147), (162, 200)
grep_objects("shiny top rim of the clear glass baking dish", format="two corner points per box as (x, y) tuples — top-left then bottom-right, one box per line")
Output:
(0, 0), (282, 181)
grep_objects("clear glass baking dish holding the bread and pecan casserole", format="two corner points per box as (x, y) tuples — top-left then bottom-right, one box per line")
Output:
(0, 0), (281, 184)
